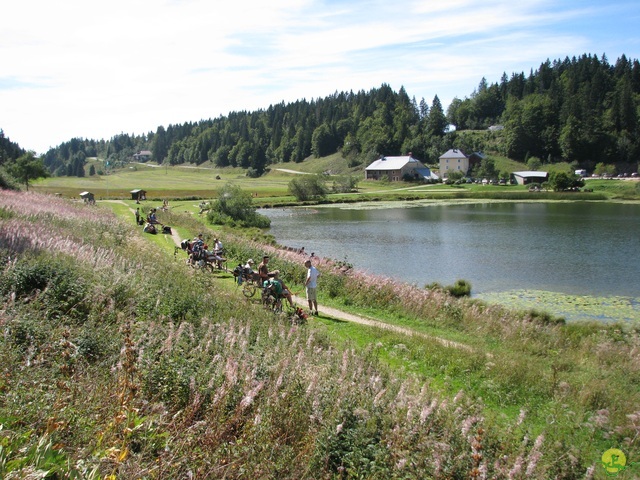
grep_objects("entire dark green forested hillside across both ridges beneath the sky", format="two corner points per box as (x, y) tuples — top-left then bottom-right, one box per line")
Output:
(5, 54), (640, 176)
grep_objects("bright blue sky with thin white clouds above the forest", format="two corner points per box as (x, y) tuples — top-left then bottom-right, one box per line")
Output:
(0, 0), (640, 154)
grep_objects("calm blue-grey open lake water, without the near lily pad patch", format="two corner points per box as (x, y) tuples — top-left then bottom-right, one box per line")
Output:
(261, 202), (640, 320)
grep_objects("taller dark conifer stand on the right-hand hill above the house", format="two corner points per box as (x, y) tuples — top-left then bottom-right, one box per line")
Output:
(447, 55), (640, 171)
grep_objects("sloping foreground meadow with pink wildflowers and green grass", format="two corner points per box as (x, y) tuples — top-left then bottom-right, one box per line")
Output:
(0, 189), (640, 479)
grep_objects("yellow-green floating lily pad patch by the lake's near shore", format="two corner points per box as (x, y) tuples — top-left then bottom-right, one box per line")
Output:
(475, 290), (640, 322)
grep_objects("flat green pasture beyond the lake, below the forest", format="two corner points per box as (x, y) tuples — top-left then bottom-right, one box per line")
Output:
(32, 158), (640, 203)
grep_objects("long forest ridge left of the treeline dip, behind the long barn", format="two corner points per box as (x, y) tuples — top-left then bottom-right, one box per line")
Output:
(27, 84), (448, 176)
